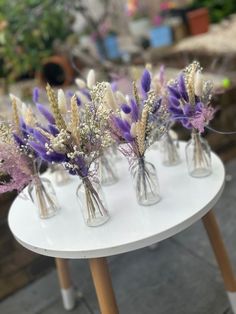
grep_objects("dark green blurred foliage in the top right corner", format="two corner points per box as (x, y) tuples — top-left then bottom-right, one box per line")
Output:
(194, 0), (236, 23)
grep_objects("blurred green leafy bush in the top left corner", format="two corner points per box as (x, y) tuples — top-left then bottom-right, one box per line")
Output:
(0, 0), (71, 81)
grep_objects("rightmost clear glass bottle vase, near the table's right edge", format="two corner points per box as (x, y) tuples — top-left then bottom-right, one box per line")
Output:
(185, 131), (212, 178)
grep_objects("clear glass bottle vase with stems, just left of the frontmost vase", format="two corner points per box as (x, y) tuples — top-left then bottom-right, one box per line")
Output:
(28, 174), (60, 219)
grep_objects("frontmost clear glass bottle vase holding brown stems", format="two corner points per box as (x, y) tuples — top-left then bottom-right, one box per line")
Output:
(76, 177), (110, 227)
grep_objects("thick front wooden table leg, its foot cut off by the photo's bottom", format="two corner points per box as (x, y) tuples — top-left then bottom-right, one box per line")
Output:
(89, 257), (119, 314)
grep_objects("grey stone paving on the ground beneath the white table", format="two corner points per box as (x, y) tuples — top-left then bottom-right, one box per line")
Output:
(0, 160), (236, 314)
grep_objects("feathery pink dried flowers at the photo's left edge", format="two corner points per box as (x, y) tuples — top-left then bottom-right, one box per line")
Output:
(0, 143), (31, 194)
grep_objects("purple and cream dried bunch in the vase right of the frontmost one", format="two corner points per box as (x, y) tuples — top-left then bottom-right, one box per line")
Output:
(109, 70), (168, 156)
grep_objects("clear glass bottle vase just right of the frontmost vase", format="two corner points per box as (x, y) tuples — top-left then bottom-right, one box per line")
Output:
(131, 157), (161, 206)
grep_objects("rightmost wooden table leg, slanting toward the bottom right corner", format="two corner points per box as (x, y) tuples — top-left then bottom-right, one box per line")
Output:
(202, 211), (236, 314)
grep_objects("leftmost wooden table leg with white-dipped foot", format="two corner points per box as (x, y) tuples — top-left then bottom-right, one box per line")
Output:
(55, 258), (75, 311)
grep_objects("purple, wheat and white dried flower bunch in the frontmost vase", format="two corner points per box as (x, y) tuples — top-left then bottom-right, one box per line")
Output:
(28, 82), (110, 178)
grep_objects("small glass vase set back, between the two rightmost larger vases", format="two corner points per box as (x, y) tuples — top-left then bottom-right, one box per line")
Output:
(161, 132), (181, 166)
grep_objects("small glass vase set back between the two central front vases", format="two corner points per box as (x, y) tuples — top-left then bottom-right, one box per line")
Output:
(99, 150), (118, 186)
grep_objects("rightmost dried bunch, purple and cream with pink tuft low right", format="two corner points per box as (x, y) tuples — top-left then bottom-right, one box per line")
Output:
(167, 61), (215, 133)
